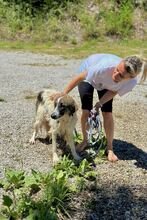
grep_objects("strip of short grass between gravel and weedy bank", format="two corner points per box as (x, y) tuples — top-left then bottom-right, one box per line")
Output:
(0, 40), (147, 58)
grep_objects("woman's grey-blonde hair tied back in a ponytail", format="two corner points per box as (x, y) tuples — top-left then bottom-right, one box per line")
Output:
(124, 55), (147, 83)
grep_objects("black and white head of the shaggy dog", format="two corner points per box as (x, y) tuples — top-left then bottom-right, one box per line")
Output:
(51, 95), (78, 119)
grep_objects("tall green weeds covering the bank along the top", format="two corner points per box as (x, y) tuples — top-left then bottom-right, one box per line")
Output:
(0, 0), (146, 42)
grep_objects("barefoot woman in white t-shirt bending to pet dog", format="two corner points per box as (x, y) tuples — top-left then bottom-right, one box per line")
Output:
(51, 54), (147, 162)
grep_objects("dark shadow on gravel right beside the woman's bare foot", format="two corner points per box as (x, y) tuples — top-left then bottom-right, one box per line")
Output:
(113, 139), (147, 170)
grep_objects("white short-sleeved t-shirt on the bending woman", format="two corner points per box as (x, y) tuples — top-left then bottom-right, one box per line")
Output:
(79, 54), (137, 96)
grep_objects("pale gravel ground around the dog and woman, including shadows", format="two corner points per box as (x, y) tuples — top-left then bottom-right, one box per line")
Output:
(0, 51), (147, 220)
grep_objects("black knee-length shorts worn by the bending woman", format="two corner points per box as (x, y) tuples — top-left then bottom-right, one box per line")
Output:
(78, 81), (113, 112)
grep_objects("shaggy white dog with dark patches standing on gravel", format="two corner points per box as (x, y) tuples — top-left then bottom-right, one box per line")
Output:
(30, 89), (80, 162)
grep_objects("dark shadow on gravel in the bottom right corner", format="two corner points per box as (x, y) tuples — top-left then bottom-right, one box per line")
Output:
(83, 185), (147, 220)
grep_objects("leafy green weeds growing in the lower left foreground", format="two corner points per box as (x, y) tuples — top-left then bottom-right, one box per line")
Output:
(0, 156), (94, 220)
